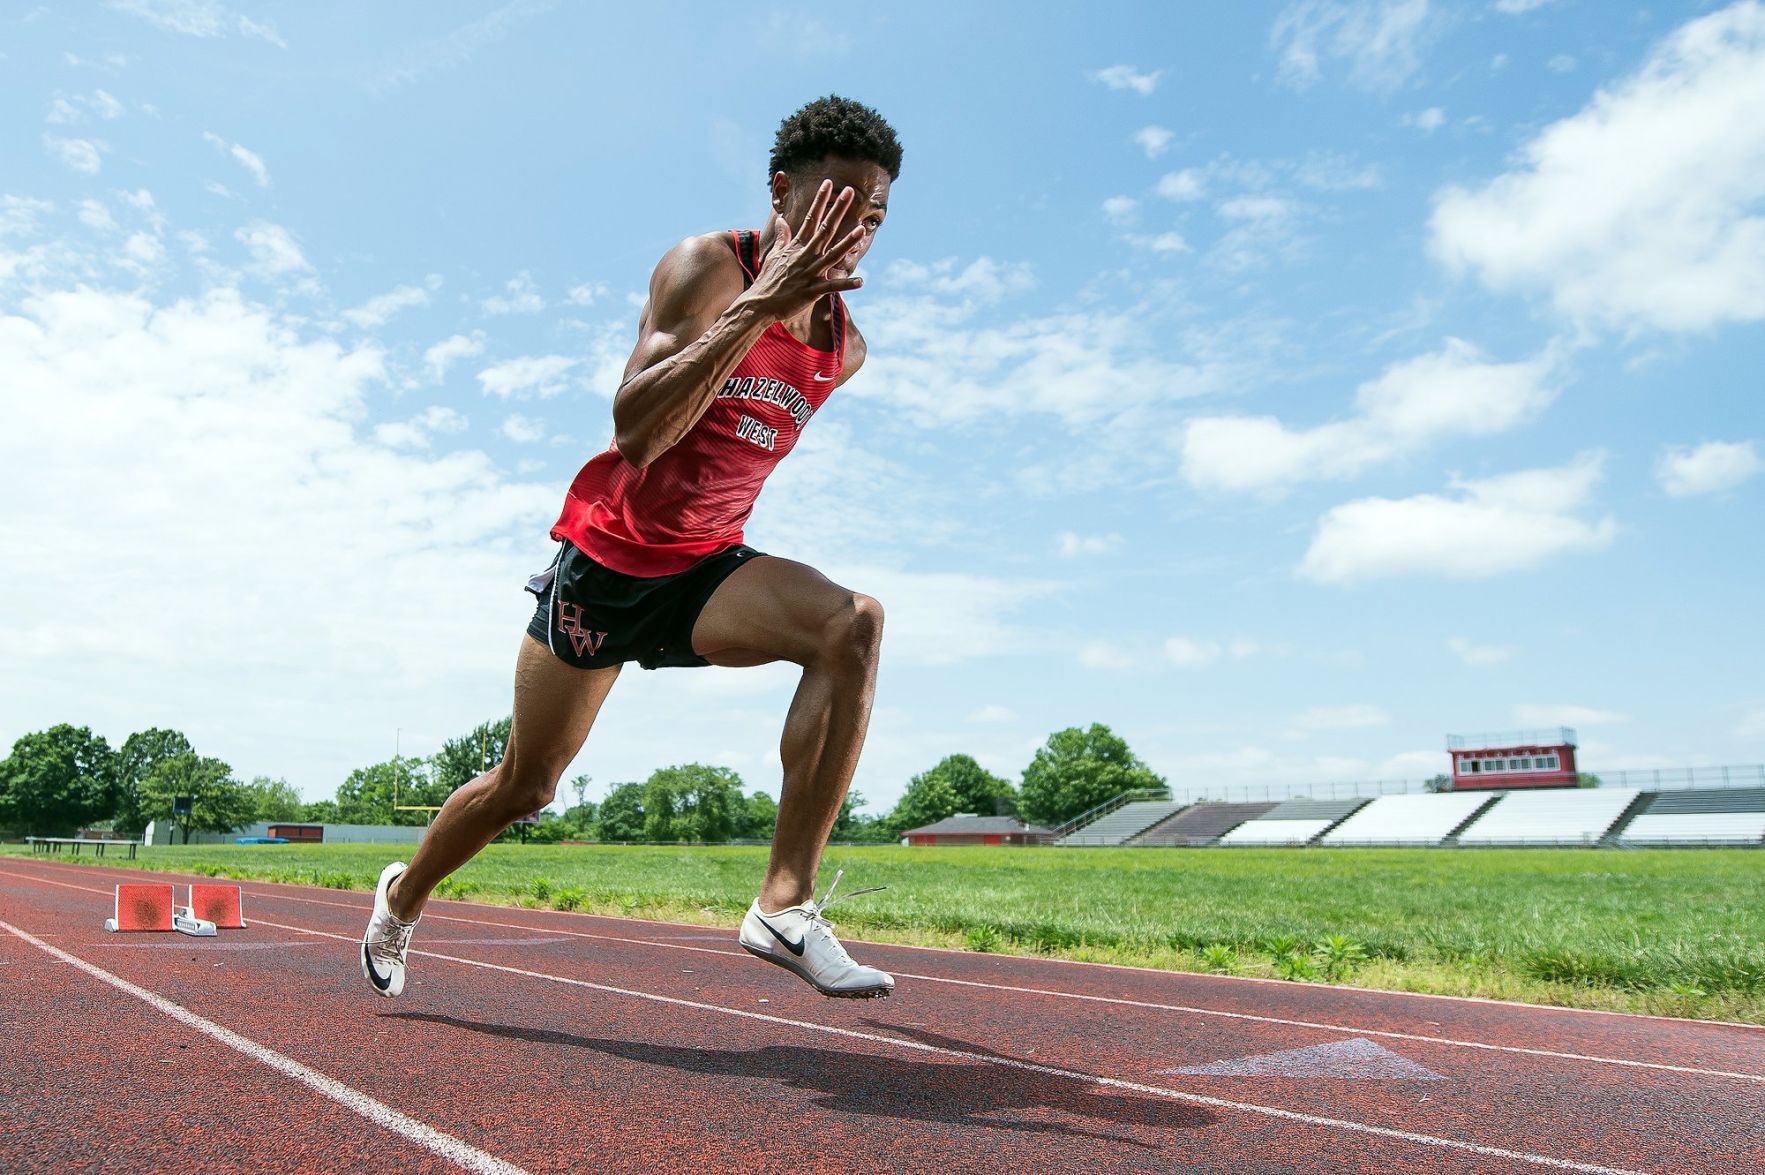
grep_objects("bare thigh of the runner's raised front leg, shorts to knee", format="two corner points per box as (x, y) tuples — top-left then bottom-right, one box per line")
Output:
(692, 556), (868, 667)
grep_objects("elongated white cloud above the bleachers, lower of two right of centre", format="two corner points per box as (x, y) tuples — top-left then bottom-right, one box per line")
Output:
(1299, 453), (1619, 584)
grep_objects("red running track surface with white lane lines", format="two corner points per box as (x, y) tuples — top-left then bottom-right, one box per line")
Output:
(0, 859), (1765, 1175)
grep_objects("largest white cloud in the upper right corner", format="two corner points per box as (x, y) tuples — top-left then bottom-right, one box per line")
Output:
(1430, 0), (1765, 330)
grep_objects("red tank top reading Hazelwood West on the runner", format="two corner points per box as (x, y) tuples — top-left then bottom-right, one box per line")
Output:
(551, 231), (845, 577)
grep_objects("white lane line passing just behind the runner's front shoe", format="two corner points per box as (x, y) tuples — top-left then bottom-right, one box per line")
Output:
(0, 870), (1765, 1083)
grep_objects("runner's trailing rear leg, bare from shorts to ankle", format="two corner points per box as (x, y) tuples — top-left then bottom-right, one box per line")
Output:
(387, 637), (620, 923)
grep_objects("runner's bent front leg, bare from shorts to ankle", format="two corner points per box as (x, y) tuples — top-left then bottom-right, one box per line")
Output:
(692, 558), (883, 910)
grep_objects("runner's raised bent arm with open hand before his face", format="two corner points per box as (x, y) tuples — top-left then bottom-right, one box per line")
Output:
(612, 183), (865, 469)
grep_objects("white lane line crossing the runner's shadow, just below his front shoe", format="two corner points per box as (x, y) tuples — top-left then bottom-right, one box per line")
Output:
(255, 917), (1643, 1175)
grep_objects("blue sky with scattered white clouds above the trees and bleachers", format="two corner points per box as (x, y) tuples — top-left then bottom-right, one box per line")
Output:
(0, 0), (1765, 806)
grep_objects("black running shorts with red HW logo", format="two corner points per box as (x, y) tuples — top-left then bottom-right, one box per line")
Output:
(528, 542), (764, 669)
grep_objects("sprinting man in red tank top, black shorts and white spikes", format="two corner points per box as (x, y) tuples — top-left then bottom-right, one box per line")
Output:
(362, 95), (900, 997)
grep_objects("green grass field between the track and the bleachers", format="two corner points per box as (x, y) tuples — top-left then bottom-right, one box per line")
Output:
(0, 845), (1765, 1023)
